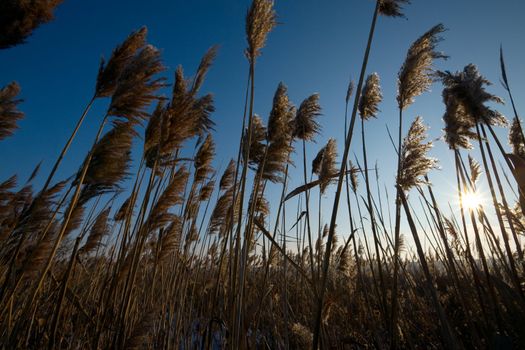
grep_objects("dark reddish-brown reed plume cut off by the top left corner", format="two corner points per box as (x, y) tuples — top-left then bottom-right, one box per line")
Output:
(0, 0), (62, 49)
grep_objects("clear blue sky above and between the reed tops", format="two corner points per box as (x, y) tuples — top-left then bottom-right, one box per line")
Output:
(0, 0), (525, 243)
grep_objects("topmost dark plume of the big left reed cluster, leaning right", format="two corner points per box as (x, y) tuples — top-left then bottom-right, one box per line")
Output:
(95, 27), (147, 97)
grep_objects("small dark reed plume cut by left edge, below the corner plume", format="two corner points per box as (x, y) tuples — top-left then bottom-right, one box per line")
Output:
(0, 82), (24, 140)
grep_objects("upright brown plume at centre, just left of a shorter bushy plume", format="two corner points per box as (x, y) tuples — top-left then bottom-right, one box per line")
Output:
(262, 83), (295, 182)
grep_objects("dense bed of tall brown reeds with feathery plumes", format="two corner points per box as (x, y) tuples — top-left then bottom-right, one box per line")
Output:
(0, 0), (525, 349)
